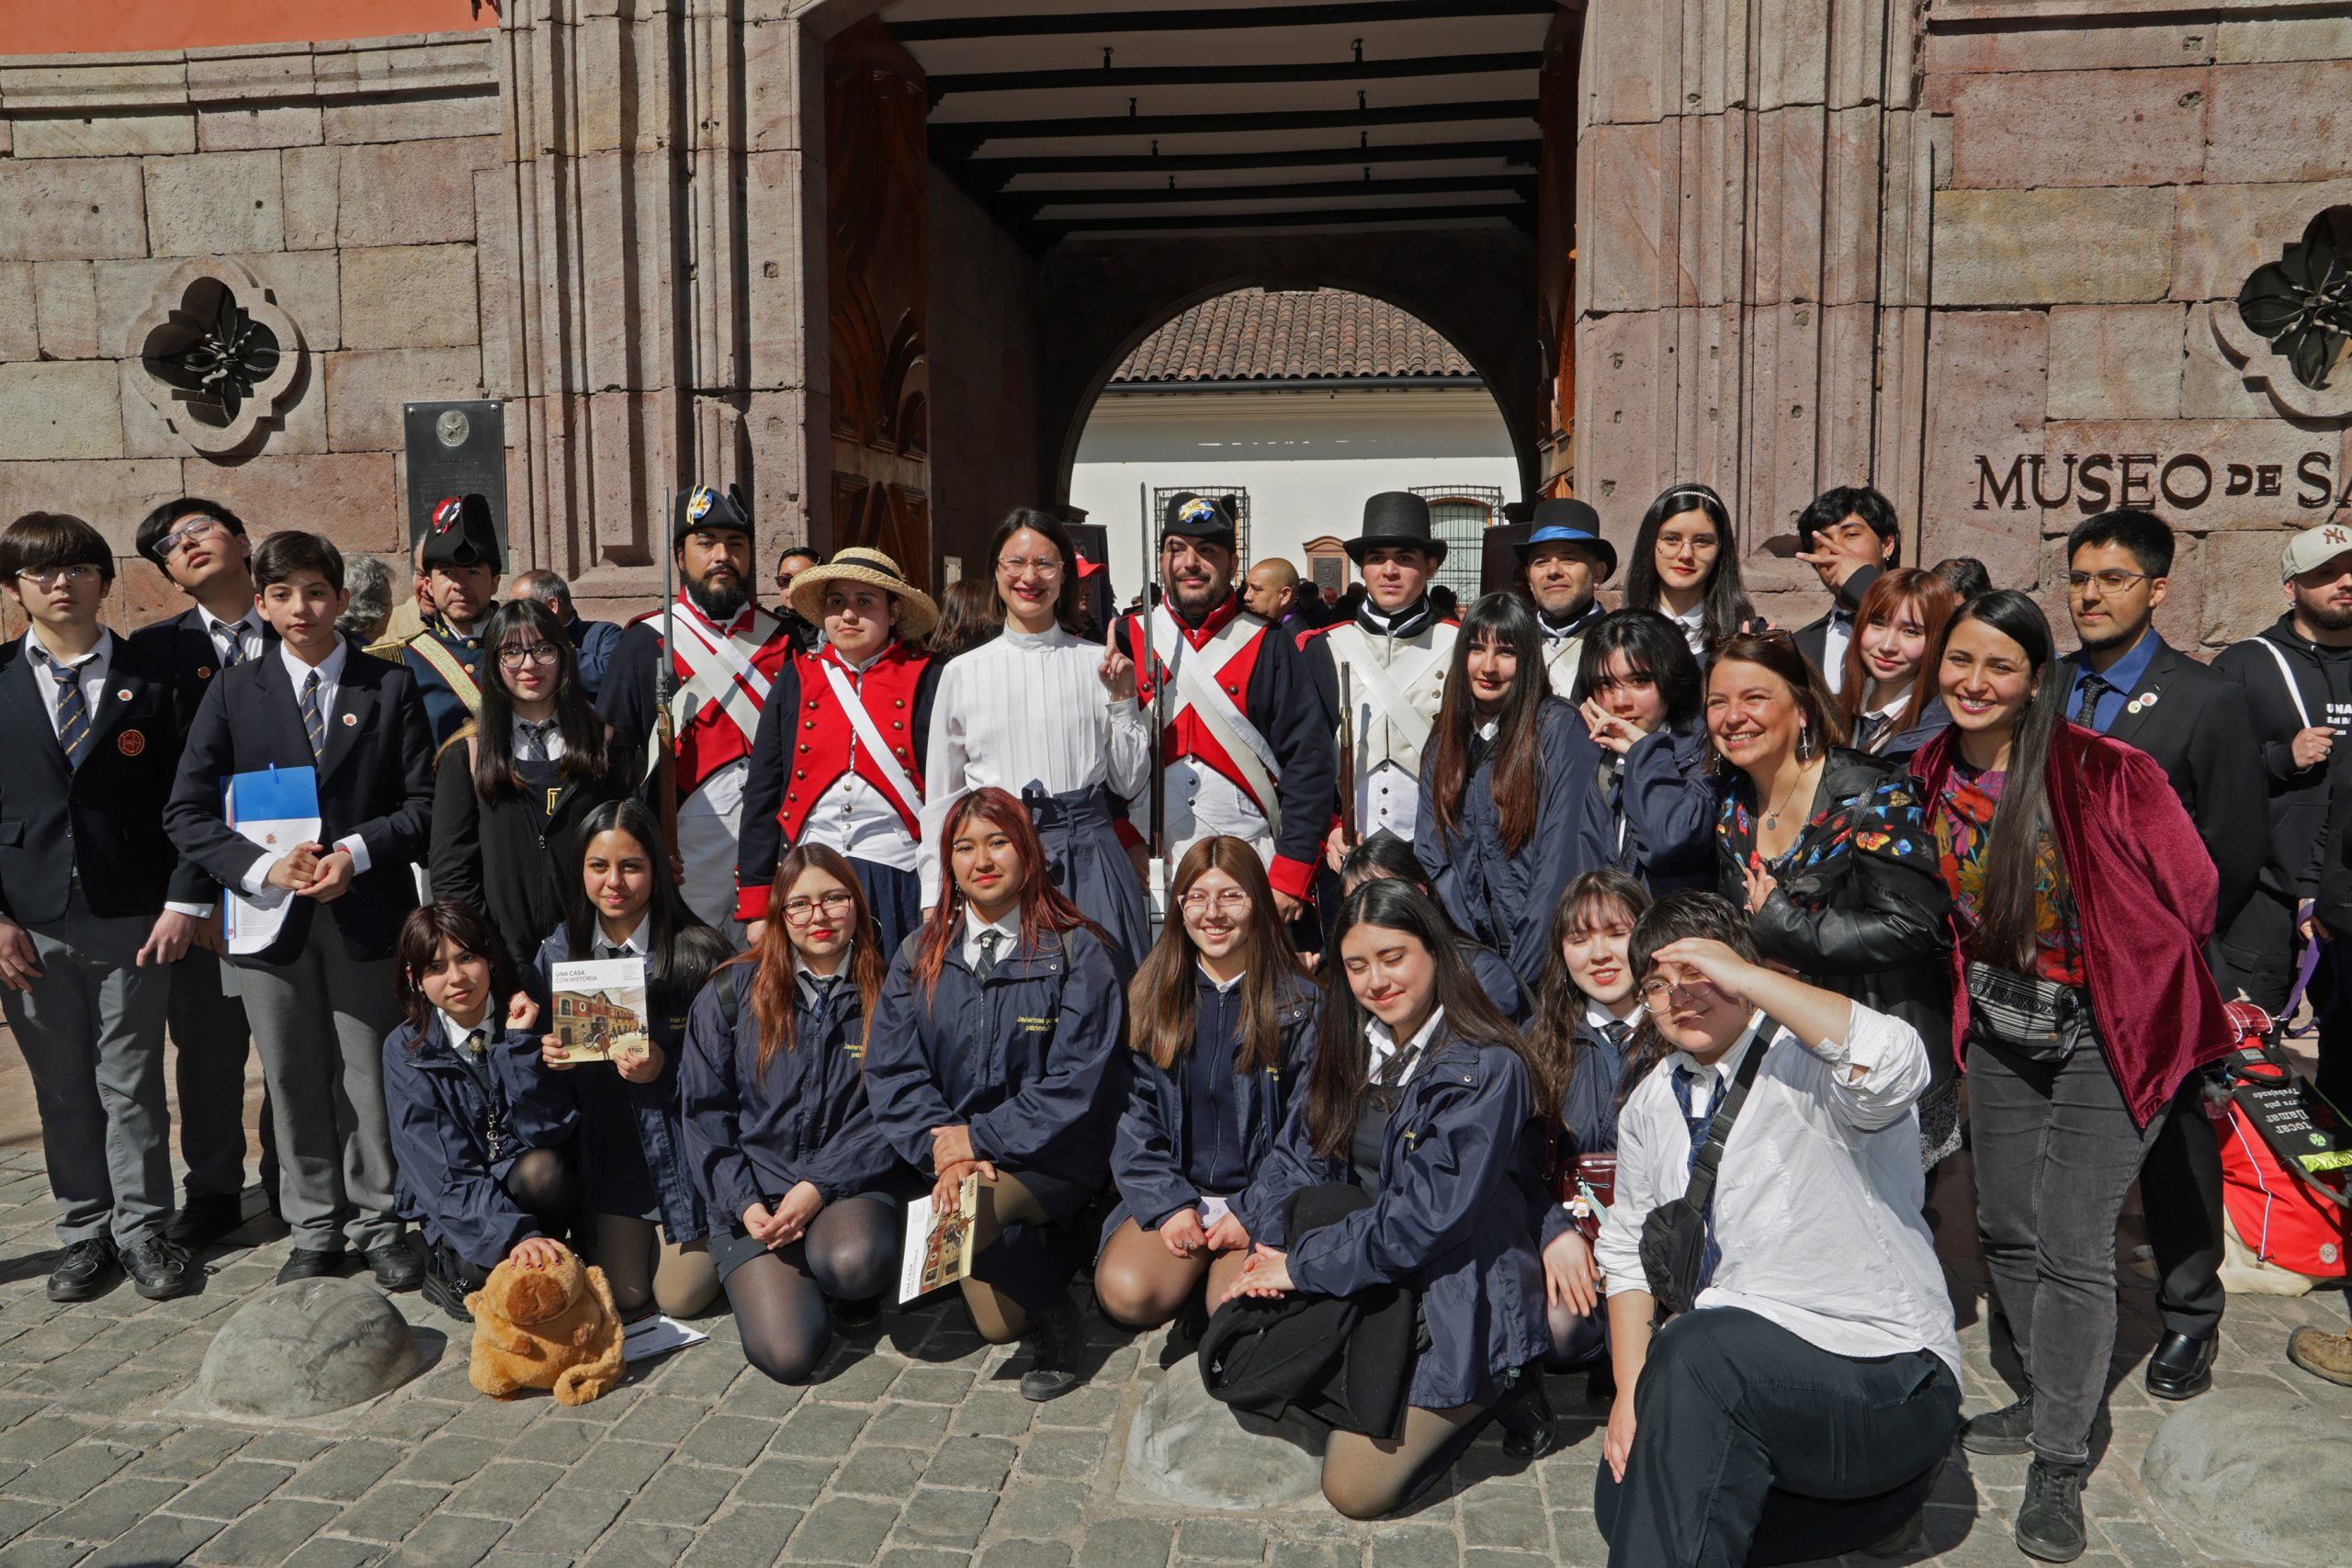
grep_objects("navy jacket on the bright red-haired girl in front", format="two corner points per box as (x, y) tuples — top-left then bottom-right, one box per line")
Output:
(865, 926), (1126, 1185)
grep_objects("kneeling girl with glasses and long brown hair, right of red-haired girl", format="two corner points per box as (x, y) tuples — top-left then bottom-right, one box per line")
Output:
(1093, 837), (1319, 1328)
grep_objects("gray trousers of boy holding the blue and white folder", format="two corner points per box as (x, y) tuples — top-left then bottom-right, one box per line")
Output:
(238, 908), (400, 1253)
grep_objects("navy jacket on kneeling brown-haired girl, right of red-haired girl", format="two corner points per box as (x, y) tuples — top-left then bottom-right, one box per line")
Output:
(1103, 968), (1322, 1244)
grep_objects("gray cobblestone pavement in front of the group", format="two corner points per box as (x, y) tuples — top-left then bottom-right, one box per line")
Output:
(0, 1152), (2352, 1568)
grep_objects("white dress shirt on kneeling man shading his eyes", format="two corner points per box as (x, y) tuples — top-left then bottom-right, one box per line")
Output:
(1592, 1004), (1959, 1378)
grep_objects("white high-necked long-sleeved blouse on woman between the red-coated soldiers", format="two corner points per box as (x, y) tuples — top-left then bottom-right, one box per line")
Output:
(922, 626), (1152, 905)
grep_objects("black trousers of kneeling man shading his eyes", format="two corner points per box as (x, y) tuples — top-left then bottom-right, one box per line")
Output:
(1592, 1307), (1959, 1568)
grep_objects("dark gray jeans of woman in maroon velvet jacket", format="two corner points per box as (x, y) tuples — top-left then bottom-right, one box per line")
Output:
(1969, 1039), (2164, 1464)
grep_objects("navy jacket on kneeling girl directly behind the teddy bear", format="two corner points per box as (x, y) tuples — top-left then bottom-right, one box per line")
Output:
(383, 1013), (579, 1267)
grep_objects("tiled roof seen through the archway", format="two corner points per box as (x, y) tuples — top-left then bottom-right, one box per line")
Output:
(1110, 289), (1477, 386)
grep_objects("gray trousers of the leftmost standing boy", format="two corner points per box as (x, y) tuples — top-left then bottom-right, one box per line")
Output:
(0, 888), (172, 1246)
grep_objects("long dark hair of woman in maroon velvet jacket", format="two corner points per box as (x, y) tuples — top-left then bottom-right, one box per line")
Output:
(1936, 588), (2065, 971)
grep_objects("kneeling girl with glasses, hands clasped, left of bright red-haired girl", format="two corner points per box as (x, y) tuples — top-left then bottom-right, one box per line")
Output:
(680, 844), (922, 1382)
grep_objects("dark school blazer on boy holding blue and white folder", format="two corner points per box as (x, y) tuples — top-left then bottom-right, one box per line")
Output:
(163, 649), (433, 964)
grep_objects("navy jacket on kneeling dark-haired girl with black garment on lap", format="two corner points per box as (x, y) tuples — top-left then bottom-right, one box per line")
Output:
(1242, 1039), (1553, 1411)
